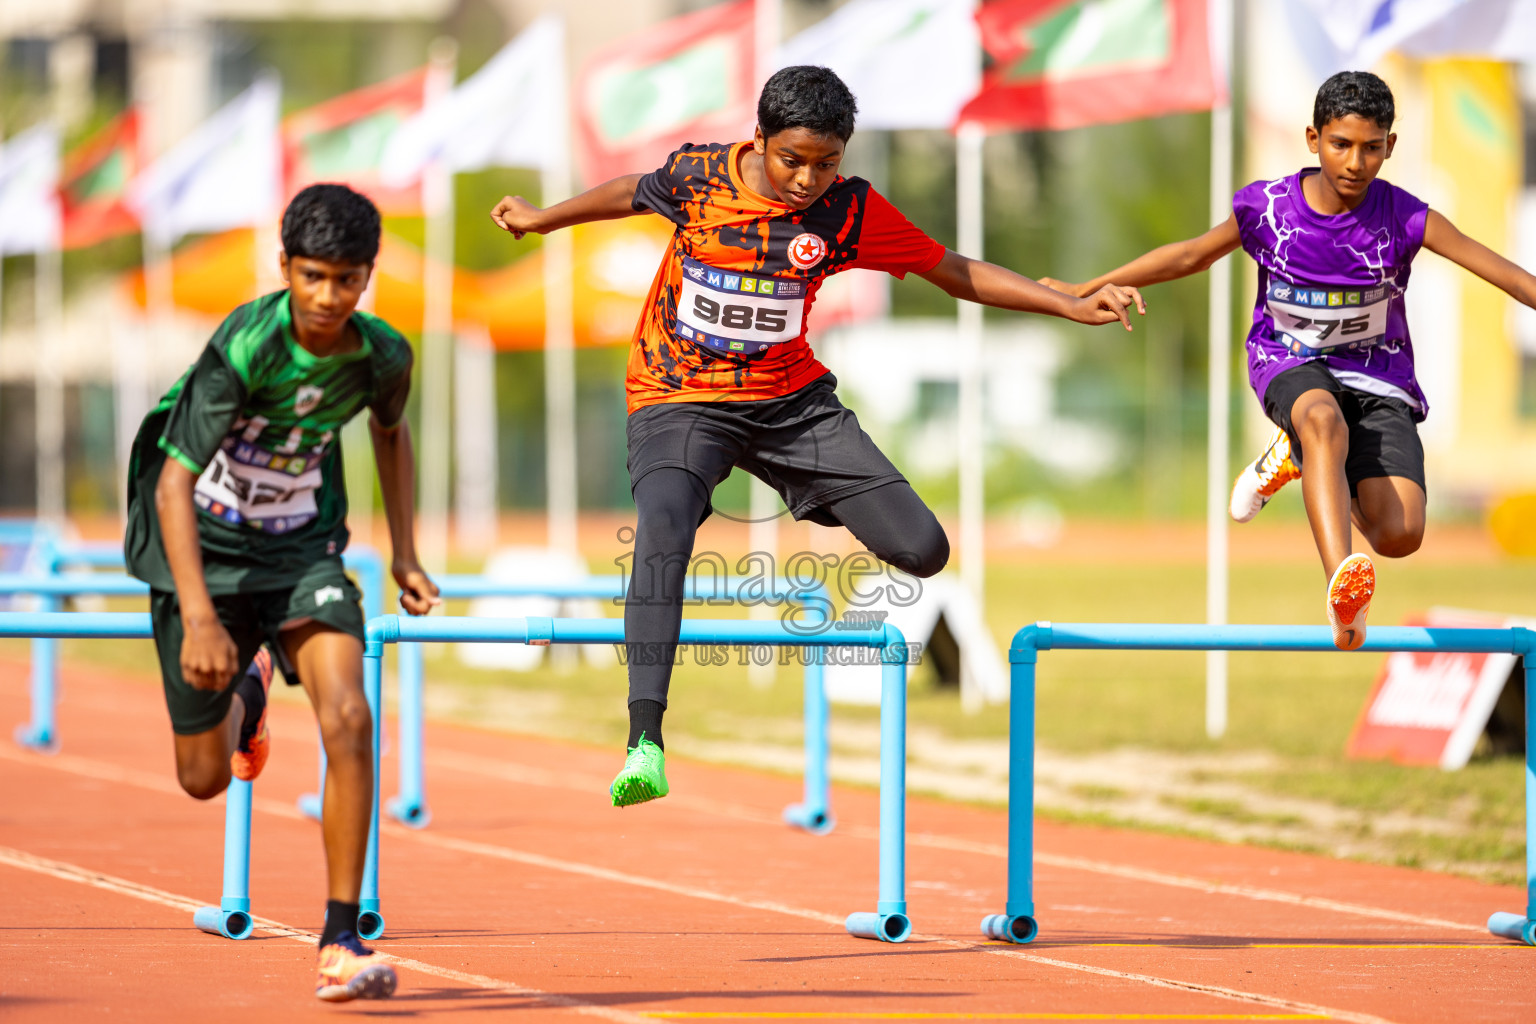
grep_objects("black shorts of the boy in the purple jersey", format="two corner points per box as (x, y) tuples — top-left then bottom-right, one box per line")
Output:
(1264, 359), (1425, 497)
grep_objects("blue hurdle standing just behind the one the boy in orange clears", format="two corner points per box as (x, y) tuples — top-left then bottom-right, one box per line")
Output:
(367, 574), (837, 835)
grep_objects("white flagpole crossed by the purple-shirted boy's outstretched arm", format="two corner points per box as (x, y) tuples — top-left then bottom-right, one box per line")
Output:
(1206, 0), (1232, 738)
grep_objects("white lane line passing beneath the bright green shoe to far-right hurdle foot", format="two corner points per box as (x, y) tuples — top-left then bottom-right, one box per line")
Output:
(427, 751), (1487, 935)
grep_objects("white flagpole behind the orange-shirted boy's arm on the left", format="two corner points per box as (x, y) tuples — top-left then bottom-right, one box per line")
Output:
(539, 16), (581, 557)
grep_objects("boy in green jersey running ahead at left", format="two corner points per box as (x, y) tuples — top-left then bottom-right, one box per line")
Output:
(124, 184), (441, 1001)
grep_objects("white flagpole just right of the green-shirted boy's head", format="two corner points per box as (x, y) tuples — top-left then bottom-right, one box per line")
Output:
(419, 37), (458, 573)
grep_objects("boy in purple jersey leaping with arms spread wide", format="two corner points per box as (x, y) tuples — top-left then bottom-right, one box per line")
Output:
(1043, 71), (1536, 651)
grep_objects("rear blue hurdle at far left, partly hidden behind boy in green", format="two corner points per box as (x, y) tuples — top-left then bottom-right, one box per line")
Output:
(0, 540), (384, 752)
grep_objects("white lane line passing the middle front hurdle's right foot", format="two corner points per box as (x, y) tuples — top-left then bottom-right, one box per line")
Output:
(0, 748), (1392, 1024)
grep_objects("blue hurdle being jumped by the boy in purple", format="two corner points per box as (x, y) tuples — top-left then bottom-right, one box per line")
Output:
(982, 622), (1536, 946)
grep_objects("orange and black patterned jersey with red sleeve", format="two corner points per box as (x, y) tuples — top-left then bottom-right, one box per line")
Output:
(625, 143), (945, 413)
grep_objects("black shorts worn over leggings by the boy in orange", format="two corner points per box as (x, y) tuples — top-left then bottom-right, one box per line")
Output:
(625, 373), (906, 527)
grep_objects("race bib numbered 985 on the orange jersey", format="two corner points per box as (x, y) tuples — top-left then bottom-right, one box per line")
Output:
(677, 256), (806, 356)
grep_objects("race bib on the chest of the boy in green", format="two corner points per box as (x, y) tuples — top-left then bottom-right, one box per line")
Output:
(192, 442), (321, 533)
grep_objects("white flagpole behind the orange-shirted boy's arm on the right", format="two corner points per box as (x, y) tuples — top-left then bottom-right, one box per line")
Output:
(955, 123), (986, 709)
